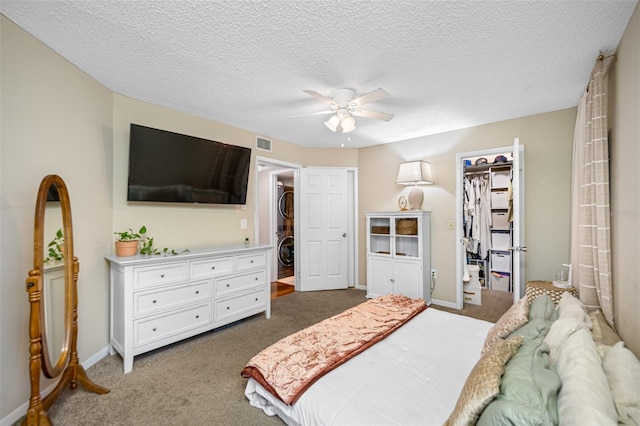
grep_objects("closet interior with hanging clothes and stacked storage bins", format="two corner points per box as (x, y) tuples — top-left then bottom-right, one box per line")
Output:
(461, 153), (513, 304)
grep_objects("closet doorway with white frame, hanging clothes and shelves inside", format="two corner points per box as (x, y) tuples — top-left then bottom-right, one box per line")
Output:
(456, 139), (526, 309)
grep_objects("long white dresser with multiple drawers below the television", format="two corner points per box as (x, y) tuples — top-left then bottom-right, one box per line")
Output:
(106, 246), (272, 373)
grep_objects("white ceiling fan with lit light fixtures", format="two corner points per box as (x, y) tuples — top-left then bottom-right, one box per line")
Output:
(291, 88), (393, 133)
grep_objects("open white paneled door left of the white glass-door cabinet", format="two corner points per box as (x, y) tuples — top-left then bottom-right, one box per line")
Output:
(296, 168), (349, 291)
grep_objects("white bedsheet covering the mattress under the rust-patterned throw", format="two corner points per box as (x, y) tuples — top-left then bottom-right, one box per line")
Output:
(245, 308), (493, 426)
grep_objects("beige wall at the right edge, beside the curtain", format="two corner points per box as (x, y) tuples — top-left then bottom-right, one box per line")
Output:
(609, 3), (640, 357)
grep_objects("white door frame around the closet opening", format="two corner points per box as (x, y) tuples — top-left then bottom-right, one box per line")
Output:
(455, 144), (525, 309)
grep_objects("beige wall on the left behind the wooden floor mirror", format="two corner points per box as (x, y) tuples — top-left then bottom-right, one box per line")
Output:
(0, 16), (113, 418)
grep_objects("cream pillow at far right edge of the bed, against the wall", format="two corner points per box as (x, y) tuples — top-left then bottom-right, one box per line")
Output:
(602, 342), (640, 425)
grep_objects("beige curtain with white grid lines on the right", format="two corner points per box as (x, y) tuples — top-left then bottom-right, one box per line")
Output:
(571, 57), (613, 326)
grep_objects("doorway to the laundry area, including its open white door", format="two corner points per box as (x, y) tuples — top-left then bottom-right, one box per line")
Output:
(254, 156), (358, 291)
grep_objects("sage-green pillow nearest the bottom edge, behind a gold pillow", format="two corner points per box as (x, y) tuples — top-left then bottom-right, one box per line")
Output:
(477, 332), (560, 426)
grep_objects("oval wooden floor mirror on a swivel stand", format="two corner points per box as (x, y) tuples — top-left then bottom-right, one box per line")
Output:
(22, 175), (109, 425)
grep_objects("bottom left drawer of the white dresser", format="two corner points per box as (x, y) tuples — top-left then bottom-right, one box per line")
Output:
(133, 303), (211, 347)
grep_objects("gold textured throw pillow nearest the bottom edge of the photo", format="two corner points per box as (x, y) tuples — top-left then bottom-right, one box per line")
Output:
(445, 336), (526, 426)
